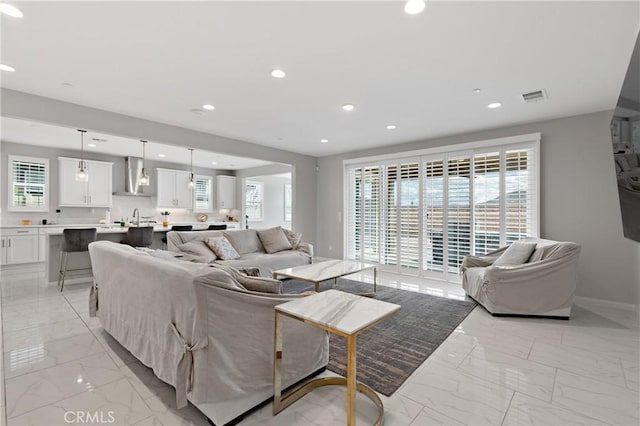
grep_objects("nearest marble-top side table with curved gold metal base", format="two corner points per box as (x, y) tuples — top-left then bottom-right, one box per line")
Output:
(273, 290), (400, 426)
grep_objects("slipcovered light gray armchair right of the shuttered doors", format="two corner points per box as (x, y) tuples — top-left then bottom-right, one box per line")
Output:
(462, 238), (580, 319)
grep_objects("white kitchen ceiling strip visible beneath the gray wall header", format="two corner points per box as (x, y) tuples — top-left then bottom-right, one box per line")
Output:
(0, 117), (273, 170)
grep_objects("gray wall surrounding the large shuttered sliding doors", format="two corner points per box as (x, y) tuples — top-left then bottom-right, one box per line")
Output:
(316, 111), (638, 303)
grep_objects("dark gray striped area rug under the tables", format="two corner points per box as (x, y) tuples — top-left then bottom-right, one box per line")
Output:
(282, 279), (476, 396)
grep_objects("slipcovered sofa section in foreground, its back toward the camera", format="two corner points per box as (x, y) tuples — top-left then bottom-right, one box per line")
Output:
(89, 241), (329, 425)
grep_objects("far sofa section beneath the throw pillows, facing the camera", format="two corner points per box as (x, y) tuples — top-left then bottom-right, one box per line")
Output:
(167, 229), (313, 277)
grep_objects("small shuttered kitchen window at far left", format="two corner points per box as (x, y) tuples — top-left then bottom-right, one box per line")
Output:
(7, 155), (49, 212)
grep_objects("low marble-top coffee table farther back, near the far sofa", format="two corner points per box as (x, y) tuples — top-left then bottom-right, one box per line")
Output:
(273, 259), (378, 293)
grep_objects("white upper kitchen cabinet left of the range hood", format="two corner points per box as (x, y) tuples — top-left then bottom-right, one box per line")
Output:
(58, 157), (113, 207)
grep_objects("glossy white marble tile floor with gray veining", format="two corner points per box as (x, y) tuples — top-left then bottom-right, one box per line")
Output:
(0, 272), (640, 426)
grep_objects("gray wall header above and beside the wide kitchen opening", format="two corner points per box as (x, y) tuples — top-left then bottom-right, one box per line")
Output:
(1, 89), (316, 243)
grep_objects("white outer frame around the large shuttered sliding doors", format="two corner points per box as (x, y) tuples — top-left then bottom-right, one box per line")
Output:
(343, 133), (541, 279)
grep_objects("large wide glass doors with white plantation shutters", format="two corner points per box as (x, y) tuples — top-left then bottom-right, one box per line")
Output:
(344, 135), (539, 279)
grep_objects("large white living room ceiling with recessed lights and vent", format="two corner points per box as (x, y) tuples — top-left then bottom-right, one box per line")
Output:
(1, 1), (640, 156)
